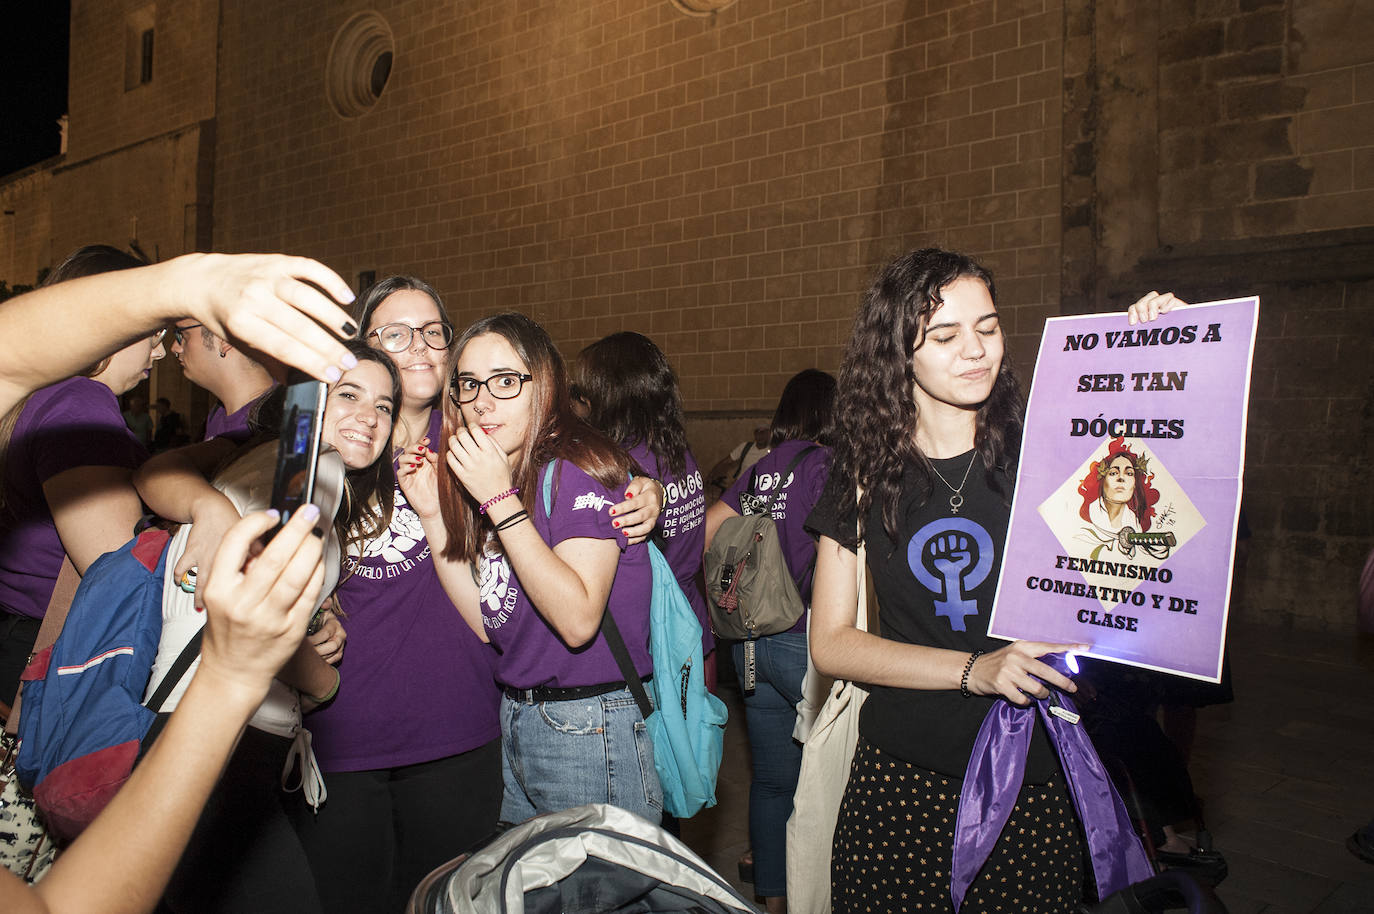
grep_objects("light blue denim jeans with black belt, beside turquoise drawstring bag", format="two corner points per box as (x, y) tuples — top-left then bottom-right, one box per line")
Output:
(502, 689), (664, 825)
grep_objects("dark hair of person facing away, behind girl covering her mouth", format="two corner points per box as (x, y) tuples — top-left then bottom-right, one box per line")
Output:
(572, 331), (687, 478)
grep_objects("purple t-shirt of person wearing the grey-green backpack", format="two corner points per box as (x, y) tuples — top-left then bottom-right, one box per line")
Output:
(720, 441), (830, 632)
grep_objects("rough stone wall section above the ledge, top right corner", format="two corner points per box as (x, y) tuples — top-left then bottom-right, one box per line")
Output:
(1160, 0), (1374, 243)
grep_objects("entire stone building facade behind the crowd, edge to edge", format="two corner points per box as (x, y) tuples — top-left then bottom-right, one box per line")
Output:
(0, 0), (1374, 628)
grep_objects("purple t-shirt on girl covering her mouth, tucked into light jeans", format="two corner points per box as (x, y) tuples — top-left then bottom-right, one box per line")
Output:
(478, 460), (654, 689)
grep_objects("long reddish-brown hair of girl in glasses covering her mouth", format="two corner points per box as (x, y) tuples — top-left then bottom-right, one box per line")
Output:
(438, 311), (633, 562)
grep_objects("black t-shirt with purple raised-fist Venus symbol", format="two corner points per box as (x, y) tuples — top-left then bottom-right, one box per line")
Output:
(807, 451), (1058, 783)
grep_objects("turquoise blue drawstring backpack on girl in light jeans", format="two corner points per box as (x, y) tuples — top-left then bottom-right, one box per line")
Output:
(544, 462), (728, 819)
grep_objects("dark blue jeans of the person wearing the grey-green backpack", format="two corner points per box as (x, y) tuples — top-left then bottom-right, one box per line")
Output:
(734, 632), (807, 898)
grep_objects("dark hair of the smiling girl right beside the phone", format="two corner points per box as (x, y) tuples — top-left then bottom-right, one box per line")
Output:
(250, 339), (401, 553)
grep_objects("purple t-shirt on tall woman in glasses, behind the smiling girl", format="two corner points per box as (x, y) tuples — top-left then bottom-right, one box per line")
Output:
(305, 410), (500, 774)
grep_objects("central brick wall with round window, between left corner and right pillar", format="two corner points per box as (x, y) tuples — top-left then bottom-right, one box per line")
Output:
(214, 0), (1061, 398)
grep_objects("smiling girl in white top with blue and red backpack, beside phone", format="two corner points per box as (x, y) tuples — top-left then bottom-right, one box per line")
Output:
(135, 342), (400, 914)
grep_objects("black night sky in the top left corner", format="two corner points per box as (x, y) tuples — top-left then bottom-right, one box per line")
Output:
(0, 6), (70, 177)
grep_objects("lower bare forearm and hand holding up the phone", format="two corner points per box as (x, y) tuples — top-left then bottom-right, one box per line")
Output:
(0, 509), (324, 914)
